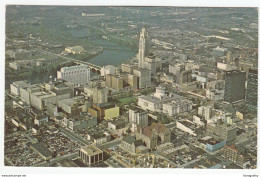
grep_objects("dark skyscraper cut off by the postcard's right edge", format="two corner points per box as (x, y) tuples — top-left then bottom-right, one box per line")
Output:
(246, 69), (258, 112)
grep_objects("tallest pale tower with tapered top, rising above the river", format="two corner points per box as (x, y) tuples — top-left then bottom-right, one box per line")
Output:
(137, 27), (148, 68)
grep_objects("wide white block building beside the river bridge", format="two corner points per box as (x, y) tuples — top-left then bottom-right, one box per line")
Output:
(57, 66), (90, 85)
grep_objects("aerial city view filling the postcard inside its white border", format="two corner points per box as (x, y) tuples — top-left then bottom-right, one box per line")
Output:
(4, 5), (258, 169)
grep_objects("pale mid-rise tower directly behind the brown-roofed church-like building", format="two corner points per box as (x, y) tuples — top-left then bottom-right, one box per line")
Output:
(129, 108), (148, 132)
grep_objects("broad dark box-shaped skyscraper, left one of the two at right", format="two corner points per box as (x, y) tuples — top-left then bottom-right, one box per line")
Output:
(224, 70), (246, 103)
